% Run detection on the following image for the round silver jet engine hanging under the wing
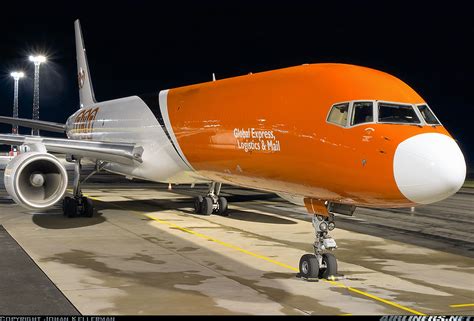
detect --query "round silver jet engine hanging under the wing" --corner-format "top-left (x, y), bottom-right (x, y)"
top-left (4, 152), bottom-right (68, 210)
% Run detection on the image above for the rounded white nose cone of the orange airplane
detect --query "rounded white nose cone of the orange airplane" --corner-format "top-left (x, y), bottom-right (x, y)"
top-left (393, 133), bottom-right (466, 204)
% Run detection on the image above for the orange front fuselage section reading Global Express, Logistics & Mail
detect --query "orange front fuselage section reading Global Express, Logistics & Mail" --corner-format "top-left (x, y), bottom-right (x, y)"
top-left (167, 64), bottom-right (449, 207)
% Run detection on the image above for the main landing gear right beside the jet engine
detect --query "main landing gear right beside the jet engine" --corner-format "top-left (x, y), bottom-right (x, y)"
top-left (63, 158), bottom-right (97, 217)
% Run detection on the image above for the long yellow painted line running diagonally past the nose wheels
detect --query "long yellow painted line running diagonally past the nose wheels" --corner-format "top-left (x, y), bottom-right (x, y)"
top-left (84, 194), bottom-right (426, 315)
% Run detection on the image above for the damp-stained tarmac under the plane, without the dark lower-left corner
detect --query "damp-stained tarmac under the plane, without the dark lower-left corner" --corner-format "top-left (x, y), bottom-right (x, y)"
top-left (0, 169), bottom-right (474, 315)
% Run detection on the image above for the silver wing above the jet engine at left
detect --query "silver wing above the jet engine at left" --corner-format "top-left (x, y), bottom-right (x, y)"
top-left (0, 134), bottom-right (143, 165)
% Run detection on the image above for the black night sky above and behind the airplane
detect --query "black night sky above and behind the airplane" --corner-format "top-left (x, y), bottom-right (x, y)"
top-left (0, 0), bottom-right (474, 168)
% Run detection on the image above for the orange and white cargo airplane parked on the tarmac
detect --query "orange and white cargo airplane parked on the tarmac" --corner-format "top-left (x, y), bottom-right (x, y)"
top-left (0, 21), bottom-right (466, 279)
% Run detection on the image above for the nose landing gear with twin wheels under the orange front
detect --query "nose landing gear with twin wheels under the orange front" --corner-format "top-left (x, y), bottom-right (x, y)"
top-left (298, 213), bottom-right (337, 280)
